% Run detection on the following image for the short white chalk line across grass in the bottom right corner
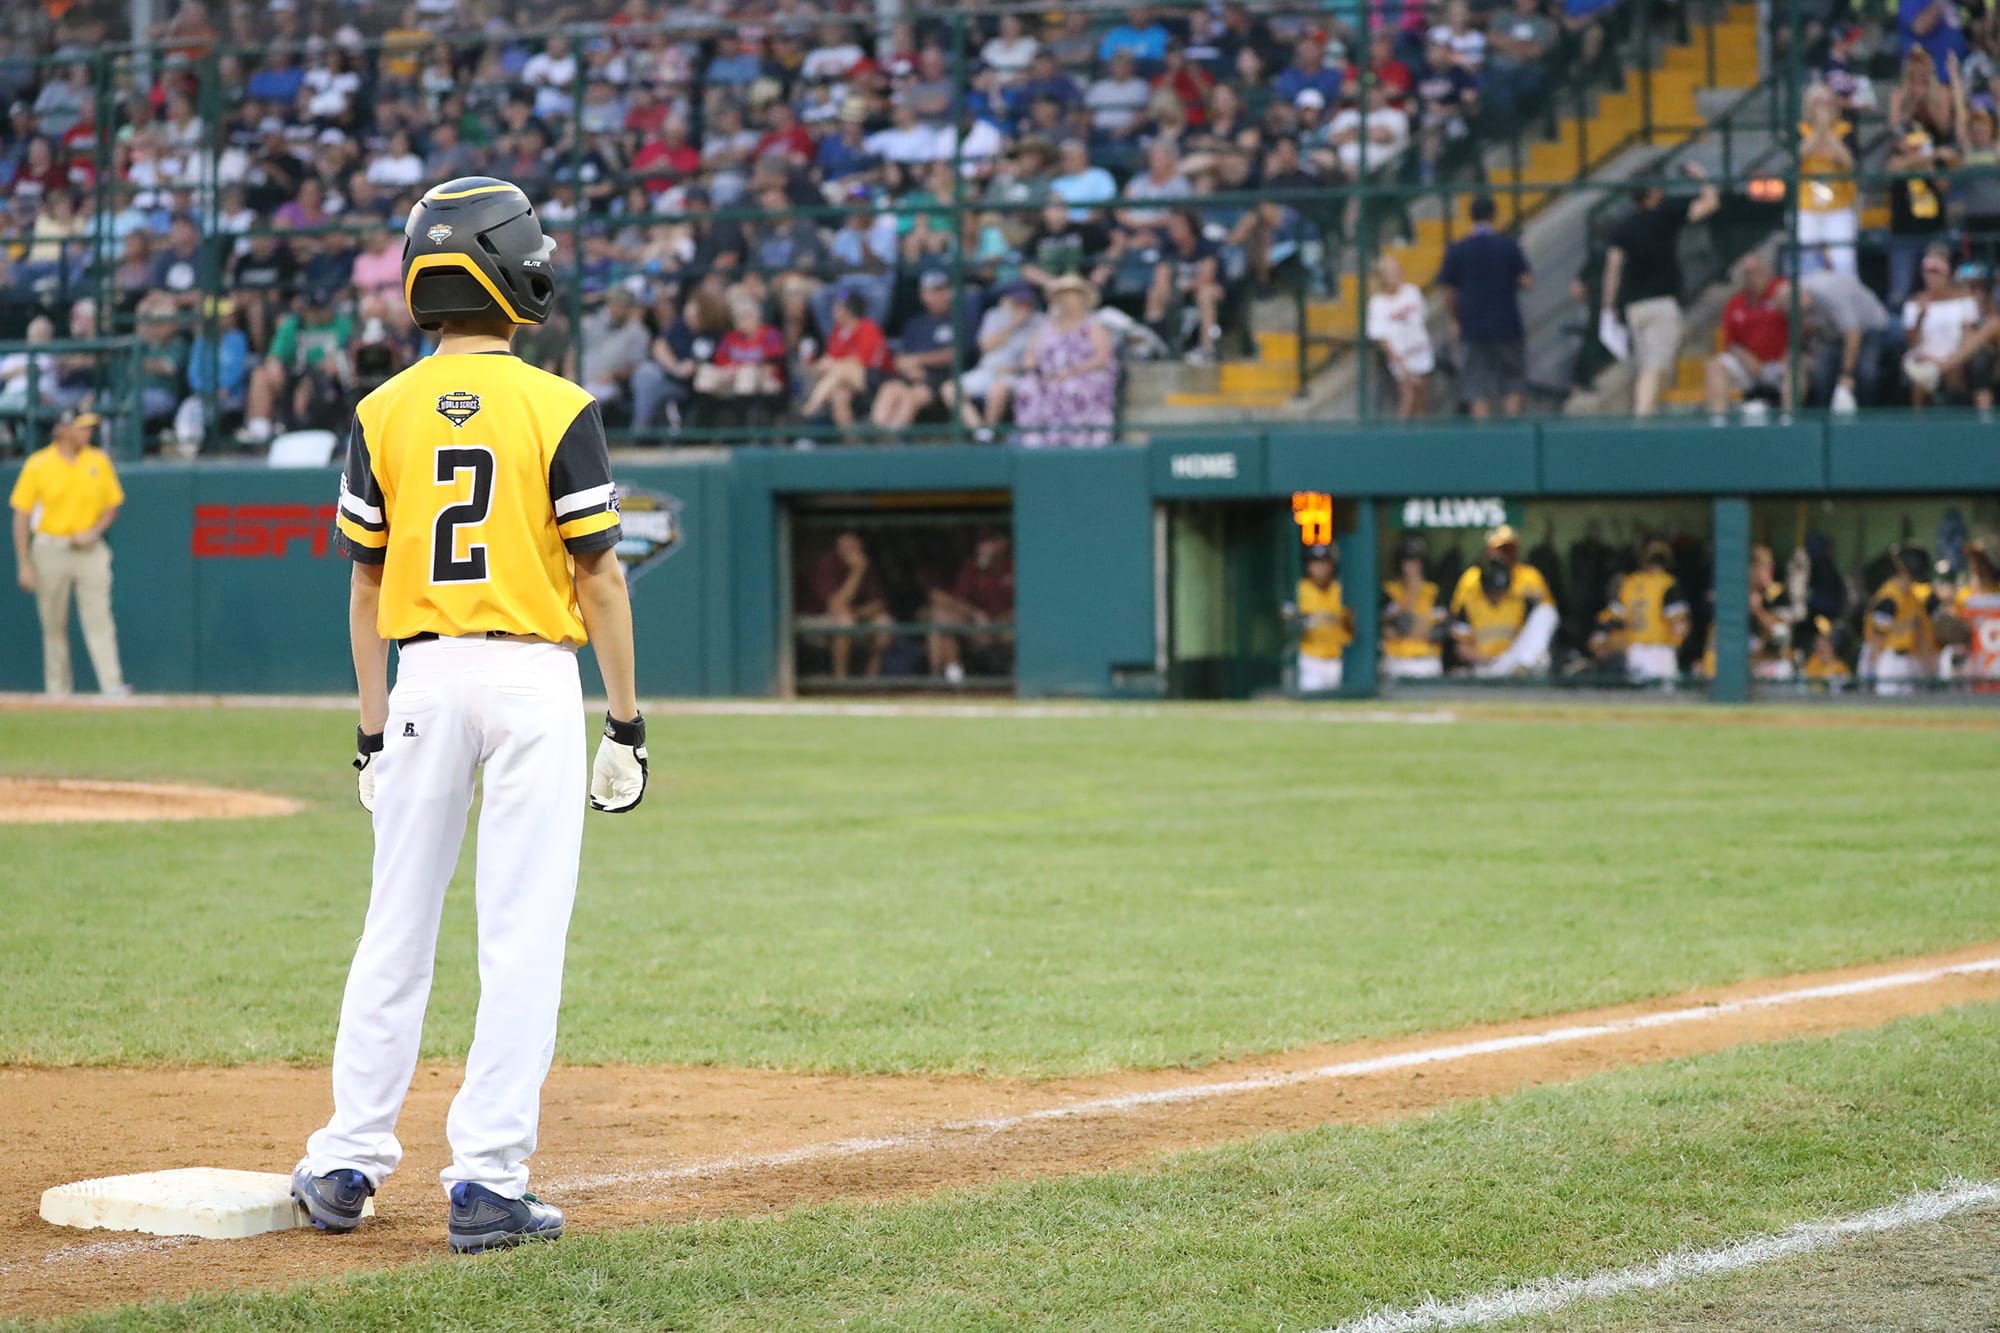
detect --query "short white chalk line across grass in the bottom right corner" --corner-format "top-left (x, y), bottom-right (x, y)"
top-left (1322, 1181), bottom-right (2000, 1333)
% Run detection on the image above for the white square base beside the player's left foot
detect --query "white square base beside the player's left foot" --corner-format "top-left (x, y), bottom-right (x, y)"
top-left (42, 1167), bottom-right (374, 1241)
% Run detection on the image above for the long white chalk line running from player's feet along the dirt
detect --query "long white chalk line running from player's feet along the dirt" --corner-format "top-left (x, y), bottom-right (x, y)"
top-left (550, 959), bottom-right (2000, 1191)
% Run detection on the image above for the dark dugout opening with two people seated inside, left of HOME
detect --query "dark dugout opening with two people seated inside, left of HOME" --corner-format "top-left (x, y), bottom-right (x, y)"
top-left (778, 490), bottom-right (1014, 697)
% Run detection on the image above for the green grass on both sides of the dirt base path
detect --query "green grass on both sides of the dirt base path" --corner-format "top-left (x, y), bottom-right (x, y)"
top-left (0, 711), bottom-right (2000, 1329)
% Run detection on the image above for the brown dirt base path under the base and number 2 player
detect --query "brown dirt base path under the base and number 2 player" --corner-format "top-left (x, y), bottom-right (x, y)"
top-left (11, 947), bottom-right (2000, 1315)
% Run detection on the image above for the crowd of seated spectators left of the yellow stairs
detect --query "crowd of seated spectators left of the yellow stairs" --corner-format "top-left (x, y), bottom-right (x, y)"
top-left (0, 0), bottom-right (1600, 448)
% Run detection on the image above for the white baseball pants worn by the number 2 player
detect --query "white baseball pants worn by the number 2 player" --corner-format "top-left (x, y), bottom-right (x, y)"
top-left (306, 638), bottom-right (588, 1197)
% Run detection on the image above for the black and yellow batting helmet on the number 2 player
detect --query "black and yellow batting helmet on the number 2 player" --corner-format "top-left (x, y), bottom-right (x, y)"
top-left (402, 176), bottom-right (556, 328)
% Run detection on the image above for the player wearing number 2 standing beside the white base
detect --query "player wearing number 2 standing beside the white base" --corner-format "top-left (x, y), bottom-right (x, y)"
top-left (292, 176), bottom-right (646, 1253)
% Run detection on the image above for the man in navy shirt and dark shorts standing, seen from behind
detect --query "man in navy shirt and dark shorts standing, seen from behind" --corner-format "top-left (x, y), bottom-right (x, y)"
top-left (1438, 193), bottom-right (1534, 418)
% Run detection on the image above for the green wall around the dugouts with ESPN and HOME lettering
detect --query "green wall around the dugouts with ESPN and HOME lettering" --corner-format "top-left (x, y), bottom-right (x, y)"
top-left (0, 414), bottom-right (2000, 701)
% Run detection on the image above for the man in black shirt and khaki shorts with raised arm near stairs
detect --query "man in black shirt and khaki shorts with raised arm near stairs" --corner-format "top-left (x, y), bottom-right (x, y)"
top-left (1602, 162), bottom-right (1722, 416)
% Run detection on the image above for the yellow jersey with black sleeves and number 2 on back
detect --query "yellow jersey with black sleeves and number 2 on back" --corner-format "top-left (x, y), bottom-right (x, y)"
top-left (336, 352), bottom-right (624, 642)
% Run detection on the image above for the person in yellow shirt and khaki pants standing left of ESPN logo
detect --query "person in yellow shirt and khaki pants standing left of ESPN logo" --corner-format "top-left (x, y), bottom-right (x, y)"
top-left (10, 410), bottom-right (130, 695)
